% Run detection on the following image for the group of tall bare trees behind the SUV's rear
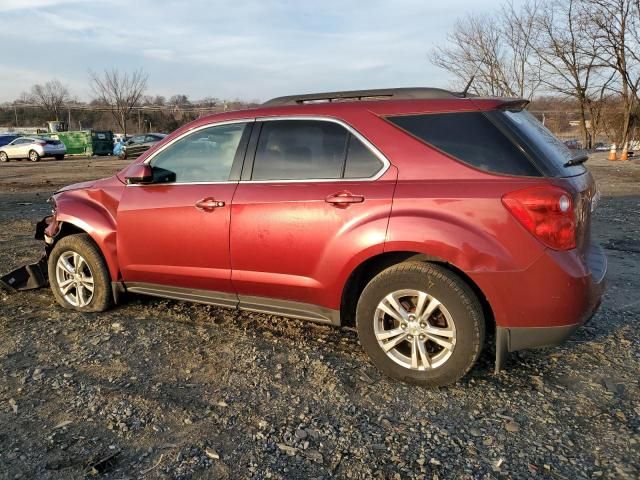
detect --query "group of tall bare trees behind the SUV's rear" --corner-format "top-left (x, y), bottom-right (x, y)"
top-left (430, 0), bottom-right (640, 147)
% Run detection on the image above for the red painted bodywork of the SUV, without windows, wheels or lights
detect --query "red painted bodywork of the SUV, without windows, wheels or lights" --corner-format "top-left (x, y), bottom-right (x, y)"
top-left (47, 99), bottom-right (602, 338)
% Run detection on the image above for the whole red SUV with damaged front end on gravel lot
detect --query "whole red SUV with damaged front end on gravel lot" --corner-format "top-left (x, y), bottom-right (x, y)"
top-left (37, 88), bottom-right (606, 385)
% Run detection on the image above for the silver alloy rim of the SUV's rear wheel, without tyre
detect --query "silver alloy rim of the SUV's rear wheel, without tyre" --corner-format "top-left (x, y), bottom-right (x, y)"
top-left (373, 290), bottom-right (456, 371)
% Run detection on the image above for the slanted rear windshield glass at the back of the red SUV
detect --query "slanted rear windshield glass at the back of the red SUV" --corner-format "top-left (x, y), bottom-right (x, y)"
top-left (502, 110), bottom-right (585, 177)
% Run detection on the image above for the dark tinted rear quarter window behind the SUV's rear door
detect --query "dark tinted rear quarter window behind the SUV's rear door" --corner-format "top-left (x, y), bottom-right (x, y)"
top-left (388, 112), bottom-right (540, 177)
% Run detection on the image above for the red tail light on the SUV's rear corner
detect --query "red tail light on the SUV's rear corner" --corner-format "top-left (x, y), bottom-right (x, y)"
top-left (502, 186), bottom-right (576, 250)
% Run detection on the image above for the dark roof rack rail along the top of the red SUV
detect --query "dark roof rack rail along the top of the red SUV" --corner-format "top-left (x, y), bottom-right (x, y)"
top-left (262, 87), bottom-right (465, 107)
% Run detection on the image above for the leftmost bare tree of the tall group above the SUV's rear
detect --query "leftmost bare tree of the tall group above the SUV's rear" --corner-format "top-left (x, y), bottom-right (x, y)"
top-left (430, 0), bottom-right (540, 98)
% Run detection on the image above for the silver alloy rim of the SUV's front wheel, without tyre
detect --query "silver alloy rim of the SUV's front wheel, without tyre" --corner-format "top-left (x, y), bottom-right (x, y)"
top-left (56, 251), bottom-right (94, 307)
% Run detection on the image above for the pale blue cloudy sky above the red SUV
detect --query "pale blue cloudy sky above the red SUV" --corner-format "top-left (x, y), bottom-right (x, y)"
top-left (0, 0), bottom-right (510, 102)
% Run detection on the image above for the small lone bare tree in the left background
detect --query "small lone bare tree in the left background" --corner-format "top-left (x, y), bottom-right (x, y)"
top-left (89, 68), bottom-right (148, 135)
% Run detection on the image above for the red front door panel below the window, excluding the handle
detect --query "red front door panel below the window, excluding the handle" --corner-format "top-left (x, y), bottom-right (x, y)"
top-left (117, 183), bottom-right (237, 292)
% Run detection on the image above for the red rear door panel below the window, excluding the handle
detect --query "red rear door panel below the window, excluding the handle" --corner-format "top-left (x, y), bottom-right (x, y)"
top-left (231, 168), bottom-right (396, 309)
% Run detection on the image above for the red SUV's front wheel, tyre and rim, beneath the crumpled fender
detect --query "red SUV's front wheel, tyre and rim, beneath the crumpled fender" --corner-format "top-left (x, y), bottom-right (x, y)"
top-left (49, 234), bottom-right (112, 312)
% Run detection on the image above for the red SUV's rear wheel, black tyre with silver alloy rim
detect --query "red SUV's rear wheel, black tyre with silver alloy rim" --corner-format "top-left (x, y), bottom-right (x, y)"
top-left (356, 262), bottom-right (485, 386)
